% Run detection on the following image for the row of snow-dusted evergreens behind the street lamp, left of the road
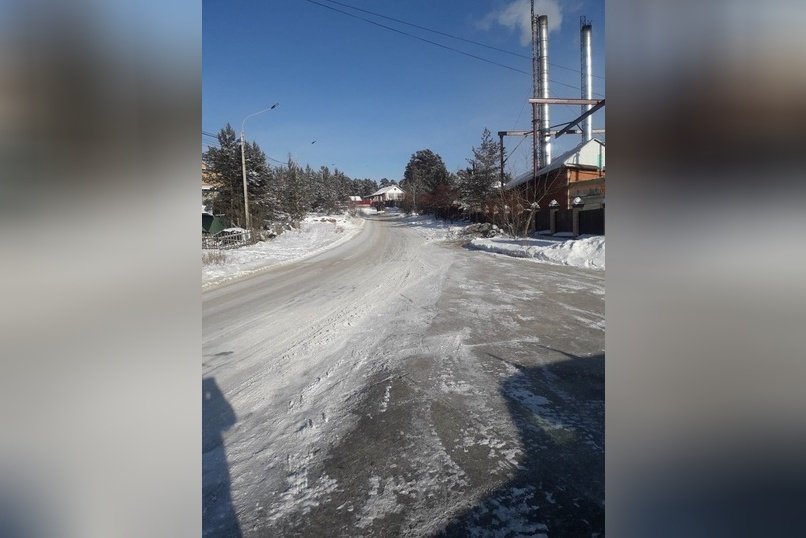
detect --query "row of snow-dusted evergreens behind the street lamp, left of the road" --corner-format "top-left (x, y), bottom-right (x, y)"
top-left (202, 124), bottom-right (393, 227)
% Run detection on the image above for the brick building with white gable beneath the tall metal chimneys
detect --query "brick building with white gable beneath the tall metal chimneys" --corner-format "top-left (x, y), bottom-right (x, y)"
top-left (504, 138), bottom-right (605, 209)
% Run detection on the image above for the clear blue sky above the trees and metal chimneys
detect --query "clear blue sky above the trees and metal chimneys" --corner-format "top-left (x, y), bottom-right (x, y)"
top-left (202, 0), bottom-right (605, 180)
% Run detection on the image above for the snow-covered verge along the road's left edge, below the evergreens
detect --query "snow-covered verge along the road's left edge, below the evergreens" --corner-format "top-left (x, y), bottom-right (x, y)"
top-left (202, 215), bottom-right (364, 288)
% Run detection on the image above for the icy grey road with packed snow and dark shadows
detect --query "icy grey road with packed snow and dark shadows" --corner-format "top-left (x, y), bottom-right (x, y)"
top-left (202, 216), bottom-right (605, 537)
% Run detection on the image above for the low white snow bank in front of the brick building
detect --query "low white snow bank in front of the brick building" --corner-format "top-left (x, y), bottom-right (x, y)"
top-left (470, 235), bottom-right (605, 270)
